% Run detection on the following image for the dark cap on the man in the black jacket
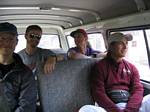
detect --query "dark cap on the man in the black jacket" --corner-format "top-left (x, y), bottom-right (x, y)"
top-left (0, 22), bottom-right (18, 35)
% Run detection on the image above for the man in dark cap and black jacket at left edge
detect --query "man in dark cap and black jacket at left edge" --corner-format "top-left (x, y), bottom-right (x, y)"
top-left (0, 22), bottom-right (37, 112)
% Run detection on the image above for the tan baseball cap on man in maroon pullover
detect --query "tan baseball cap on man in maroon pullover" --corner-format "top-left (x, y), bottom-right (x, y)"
top-left (108, 32), bottom-right (133, 44)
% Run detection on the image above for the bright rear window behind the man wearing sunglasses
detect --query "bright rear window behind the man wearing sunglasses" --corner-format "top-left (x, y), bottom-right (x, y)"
top-left (15, 35), bottom-right (60, 52)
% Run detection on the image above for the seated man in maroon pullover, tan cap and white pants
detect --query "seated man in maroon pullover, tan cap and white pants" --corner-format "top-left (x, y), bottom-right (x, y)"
top-left (79, 33), bottom-right (150, 112)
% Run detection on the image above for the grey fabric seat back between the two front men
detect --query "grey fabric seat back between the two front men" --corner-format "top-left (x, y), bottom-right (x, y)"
top-left (38, 59), bottom-right (96, 112)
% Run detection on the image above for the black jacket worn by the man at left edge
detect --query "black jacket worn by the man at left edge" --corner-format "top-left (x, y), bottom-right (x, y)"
top-left (0, 53), bottom-right (37, 112)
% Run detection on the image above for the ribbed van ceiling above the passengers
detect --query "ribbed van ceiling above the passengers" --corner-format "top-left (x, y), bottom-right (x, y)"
top-left (0, 0), bottom-right (150, 29)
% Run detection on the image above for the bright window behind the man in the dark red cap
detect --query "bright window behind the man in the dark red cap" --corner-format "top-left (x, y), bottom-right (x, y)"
top-left (67, 33), bottom-right (106, 52)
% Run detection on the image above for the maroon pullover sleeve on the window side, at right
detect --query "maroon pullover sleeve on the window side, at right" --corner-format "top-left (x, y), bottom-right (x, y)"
top-left (125, 65), bottom-right (143, 112)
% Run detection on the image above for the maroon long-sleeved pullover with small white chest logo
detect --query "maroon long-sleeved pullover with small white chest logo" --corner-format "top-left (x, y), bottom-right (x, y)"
top-left (92, 57), bottom-right (143, 112)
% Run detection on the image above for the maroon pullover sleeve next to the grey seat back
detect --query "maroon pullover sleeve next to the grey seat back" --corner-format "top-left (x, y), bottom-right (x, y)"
top-left (91, 64), bottom-right (123, 112)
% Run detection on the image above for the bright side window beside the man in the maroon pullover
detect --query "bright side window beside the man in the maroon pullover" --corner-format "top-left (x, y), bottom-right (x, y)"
top-left (112, 30), bottom-right (150, 81)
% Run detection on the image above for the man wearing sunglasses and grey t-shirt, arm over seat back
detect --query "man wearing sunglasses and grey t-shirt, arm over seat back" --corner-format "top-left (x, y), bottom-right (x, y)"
top-left (19, 25), bottom-right (60, 74)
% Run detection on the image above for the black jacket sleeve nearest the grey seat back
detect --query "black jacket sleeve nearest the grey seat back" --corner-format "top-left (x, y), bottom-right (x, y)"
top-left (15, 70), bottom-right (37, 112)
